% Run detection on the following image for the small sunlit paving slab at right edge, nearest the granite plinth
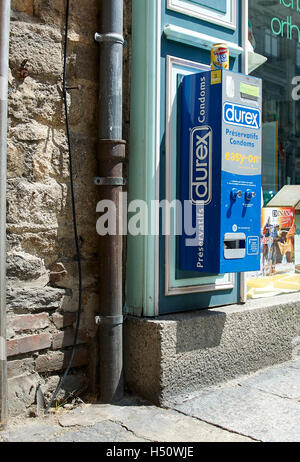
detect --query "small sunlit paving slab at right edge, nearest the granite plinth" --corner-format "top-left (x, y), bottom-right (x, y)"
top-left (241, 361), bottom-right (300, 400)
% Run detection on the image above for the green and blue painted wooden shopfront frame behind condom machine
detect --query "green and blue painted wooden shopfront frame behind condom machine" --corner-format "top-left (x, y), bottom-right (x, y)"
top-left (126, 0), bottom-right (247, 317)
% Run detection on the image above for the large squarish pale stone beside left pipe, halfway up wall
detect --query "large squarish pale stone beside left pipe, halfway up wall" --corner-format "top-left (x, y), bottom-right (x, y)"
top-left (7, 179), bottom-right (65, 232)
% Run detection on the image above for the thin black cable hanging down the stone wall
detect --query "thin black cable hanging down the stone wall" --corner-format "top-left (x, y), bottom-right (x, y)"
top-left (45, 0), bottom-right (82, 414)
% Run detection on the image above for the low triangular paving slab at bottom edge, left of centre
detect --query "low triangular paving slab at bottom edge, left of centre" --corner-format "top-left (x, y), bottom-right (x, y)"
top-left (50, 421), bottom-right (146, 443)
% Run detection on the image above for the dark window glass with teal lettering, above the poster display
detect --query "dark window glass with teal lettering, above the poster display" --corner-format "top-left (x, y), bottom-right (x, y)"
top-left (249, 0), bottom-right (300, 199)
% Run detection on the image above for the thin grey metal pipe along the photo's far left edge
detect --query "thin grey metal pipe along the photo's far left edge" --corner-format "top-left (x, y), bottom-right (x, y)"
top-left (0, 0), bottom-right (10, 430)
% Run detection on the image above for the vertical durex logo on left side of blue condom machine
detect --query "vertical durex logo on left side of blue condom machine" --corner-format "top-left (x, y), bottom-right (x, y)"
top-left (190, 125), bottom-right (213, 205)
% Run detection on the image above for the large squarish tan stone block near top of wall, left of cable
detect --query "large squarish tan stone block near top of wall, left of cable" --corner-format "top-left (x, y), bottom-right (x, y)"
top-left (9, 21), bottom-right (62, 81)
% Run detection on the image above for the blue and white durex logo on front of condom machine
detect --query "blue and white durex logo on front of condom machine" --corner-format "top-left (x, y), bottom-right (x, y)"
top-left (223, 103), bottom-right (261, 130)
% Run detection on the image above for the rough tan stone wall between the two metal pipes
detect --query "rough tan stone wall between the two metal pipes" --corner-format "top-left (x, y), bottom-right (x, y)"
top-left (7, 0), bottom-right (100, 415)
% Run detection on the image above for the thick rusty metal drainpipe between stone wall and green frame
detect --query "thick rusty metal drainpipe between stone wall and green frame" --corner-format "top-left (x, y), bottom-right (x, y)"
top-left (95, 0), bottom-right (125, 403)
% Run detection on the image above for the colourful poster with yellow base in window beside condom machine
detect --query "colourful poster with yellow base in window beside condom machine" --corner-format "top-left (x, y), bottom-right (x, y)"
top-left (247, 207), bottom-right (300, 298)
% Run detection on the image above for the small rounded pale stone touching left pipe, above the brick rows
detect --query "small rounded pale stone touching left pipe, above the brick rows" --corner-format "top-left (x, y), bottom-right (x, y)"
top-left (6, 251), bottom-right (47, 281)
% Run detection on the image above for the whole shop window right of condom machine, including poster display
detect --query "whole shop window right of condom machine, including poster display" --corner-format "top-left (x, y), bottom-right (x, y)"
top-left (248, 0), bottom-right (300, 298)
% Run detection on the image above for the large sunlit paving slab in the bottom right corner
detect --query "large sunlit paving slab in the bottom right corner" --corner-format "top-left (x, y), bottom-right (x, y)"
top-left (175, 386), bottom-right (300, 442)
